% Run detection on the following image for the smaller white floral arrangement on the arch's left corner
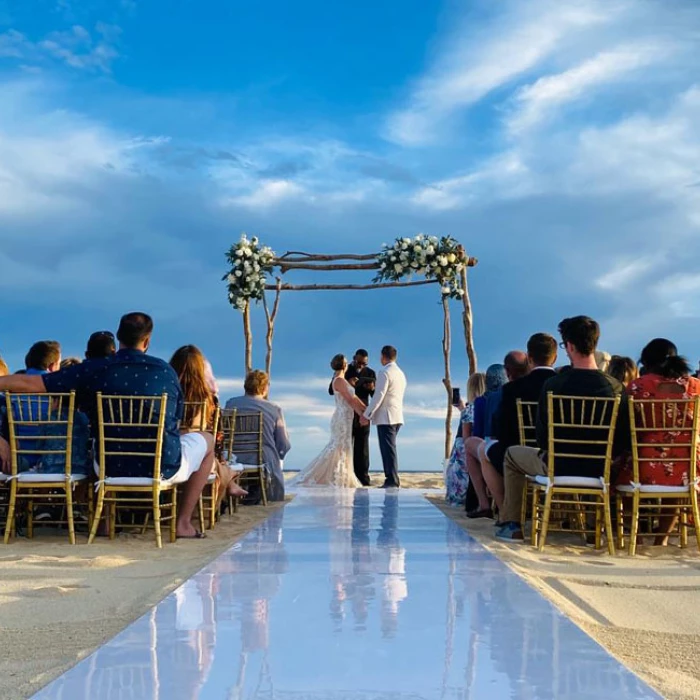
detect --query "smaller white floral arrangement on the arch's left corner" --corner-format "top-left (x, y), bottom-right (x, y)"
top-left (223, 233), bottom-right (275, 311)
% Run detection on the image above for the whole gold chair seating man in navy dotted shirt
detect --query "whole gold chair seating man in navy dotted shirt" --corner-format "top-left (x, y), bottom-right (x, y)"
top-left (88, 392), bottom-right (177, 548)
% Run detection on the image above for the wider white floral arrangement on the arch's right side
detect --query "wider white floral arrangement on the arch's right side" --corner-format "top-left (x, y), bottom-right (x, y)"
top-left (374, 233), bottom-right (467, 299)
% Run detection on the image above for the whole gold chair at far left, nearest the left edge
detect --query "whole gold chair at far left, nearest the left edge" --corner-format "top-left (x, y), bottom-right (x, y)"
top-left (5, 391), bottom-right (87, 544)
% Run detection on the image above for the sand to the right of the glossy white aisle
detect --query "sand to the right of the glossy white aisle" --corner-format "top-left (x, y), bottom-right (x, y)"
top-left (429, 495), bottom-right (700, 700)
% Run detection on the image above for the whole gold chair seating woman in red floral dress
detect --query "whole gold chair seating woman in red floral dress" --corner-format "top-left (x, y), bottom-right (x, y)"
top-left (617, 396), bottom-right (700, 555)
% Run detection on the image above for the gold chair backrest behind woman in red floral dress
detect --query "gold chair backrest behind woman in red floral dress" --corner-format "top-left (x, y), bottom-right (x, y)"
top-left (629, 396), bottom-right (700, 486)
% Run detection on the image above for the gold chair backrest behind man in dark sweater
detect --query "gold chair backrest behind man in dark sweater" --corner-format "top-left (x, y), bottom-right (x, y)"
top-left (547, 391), bottom-right (621, 484)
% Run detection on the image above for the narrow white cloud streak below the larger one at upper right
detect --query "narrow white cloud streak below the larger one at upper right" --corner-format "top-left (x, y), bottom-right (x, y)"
top-left (507, 43), bottom-right (671, 134)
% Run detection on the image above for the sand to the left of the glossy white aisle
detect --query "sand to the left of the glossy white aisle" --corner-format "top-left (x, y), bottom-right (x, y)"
top-left (0, 504), bottom-right (280, 700)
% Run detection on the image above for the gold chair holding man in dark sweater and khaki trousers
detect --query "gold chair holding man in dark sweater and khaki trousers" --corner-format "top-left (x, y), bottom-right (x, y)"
top-left (532, 392), bottom-right (620, 554)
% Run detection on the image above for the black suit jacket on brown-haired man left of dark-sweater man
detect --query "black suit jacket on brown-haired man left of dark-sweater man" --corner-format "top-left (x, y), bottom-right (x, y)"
top-left (488, 367), bottom-right (555, 474)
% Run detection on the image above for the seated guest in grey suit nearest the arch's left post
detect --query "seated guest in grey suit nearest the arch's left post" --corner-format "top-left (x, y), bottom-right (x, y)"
top-left (226, 370), bottom-right (292, 501)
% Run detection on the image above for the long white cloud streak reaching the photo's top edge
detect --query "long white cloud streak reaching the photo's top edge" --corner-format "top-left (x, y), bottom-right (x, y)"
top-left (386, 0), bottom-right (617, 146)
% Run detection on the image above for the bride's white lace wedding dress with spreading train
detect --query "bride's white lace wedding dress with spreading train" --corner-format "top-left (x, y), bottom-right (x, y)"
top-left (293, 387), bottom-right (362, 489)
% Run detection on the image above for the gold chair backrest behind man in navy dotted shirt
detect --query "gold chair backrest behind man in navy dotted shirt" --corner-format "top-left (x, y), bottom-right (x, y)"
top-left (97, 392), bottom-right (168, 481)
